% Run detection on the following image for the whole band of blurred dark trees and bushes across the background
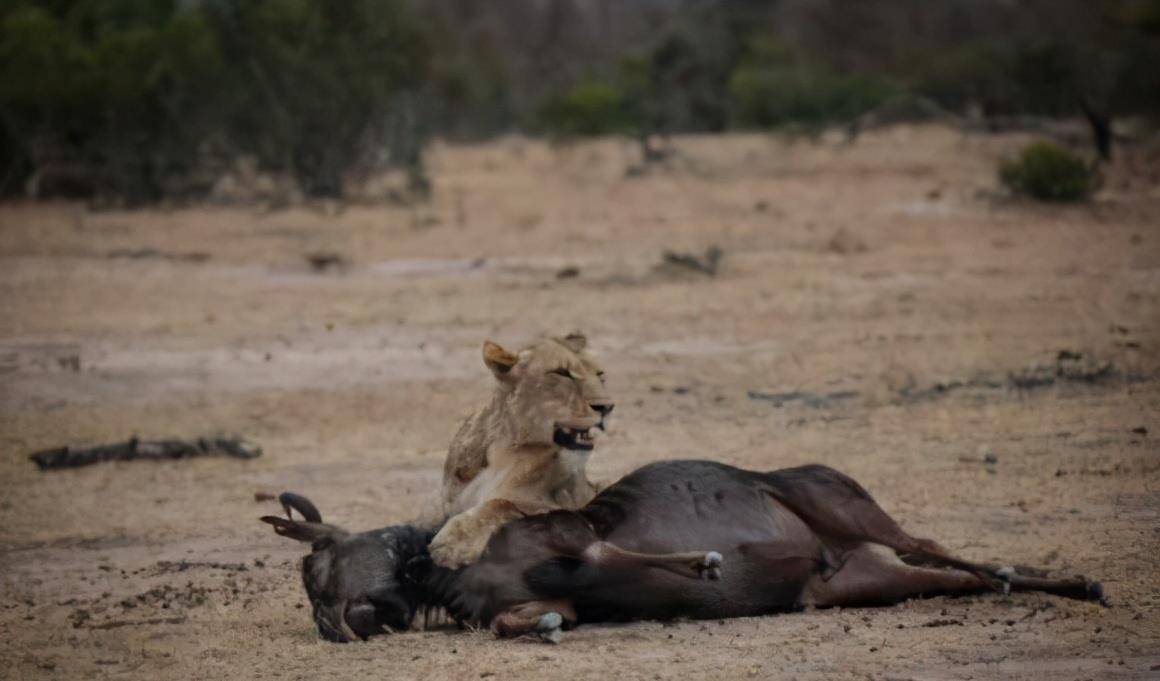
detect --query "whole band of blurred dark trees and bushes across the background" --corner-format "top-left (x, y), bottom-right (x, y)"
top-left (0, 0), bottom-right (1160, 204)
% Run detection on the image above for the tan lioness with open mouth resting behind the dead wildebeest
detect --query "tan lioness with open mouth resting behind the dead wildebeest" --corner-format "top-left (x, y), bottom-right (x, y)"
top-left (430, 333), bottom-right (614, 567)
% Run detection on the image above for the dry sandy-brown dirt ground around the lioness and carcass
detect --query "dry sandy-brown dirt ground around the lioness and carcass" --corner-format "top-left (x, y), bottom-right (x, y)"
top-left (0, 128), bottom-right (1160, 680)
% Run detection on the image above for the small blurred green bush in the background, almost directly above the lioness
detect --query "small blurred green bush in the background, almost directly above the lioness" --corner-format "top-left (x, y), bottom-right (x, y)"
top-left (539, 80), bottom-right (633, 136)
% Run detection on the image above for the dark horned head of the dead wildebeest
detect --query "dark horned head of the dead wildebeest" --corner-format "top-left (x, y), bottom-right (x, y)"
top-left (261, 492), bottom-right (432, 643)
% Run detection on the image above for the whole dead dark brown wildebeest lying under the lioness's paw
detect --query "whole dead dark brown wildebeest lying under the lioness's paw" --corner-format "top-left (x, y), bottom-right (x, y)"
top-left (263, 461), bottom-right (1102, 640)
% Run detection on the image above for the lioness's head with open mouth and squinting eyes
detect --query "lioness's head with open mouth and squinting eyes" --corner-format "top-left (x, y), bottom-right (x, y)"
top-left (484, 333), bottom-right (615, 451)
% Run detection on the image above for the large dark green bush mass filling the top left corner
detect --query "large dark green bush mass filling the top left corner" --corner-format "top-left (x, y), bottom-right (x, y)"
top-left (0, 0), bottom-right (430, 202)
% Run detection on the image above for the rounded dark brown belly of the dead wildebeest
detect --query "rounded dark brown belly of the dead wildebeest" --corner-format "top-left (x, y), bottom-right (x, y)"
top-left (575, 462), bottom-right (822, 621)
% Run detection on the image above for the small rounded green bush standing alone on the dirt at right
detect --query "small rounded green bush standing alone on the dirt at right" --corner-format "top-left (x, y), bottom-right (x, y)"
top-left (999, 142), bottom-right (1100, 201)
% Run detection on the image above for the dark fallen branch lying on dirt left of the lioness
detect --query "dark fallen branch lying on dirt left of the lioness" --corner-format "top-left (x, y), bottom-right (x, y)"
top-left (29, 437), bottom-right (262, 471)
